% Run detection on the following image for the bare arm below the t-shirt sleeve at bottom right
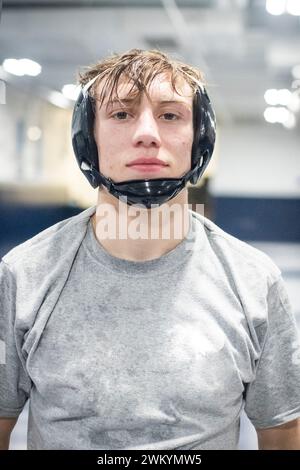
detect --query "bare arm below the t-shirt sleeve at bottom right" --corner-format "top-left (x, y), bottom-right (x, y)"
top-left (256, 418), bottom-right (300, 450)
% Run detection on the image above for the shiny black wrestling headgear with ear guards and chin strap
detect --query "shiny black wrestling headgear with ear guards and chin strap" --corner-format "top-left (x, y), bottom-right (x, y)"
top-left (72, 77), bottom-right (216, 208)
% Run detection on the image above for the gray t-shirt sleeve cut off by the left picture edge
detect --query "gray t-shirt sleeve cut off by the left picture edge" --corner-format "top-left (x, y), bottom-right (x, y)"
top-left (0, 261), bottom-right (31, 418)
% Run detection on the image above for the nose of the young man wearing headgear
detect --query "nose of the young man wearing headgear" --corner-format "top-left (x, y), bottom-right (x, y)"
top-left (133, 110), bottom-right (161, 147)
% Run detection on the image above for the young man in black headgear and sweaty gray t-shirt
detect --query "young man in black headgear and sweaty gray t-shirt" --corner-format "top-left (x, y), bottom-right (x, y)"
top-left (0, 49), bottom-right (300, 449)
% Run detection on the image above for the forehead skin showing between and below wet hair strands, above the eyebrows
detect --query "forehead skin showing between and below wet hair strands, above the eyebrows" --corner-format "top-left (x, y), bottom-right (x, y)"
top-left (97, 74), bottom-right (194, 104)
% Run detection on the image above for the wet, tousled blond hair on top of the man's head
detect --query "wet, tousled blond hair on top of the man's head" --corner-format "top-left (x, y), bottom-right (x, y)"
top-left (79, 49), bottom-right (204, 106)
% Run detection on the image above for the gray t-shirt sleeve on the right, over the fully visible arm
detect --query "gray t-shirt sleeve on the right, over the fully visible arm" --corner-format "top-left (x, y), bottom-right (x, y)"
top-left (245, 276), bottom-right (300, 429)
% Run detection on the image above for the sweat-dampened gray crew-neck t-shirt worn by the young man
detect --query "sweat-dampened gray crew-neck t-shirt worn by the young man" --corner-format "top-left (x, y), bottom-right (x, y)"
top-left (0, 208), bottom-right (300, 450)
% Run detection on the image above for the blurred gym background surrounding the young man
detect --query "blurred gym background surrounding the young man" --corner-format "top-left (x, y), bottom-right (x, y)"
top-left (0, 0), bottom-right (300, 449)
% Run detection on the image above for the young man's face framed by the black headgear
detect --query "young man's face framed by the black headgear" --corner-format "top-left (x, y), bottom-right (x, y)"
top-left (94, 75), bottom-right (193, 182)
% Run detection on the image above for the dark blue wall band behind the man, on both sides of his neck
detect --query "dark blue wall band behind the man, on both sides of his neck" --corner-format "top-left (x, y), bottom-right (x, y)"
top-left (0, 197), bottom-right (300, 256)
